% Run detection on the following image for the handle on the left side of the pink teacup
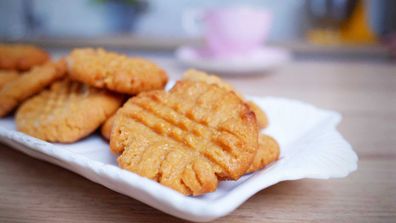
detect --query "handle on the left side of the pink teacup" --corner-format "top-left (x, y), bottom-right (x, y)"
top-left (182, 9), bottom-right (204, 36)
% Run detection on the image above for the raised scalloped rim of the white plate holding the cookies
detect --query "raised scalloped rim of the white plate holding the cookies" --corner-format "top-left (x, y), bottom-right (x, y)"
top-left (0, 96), bottom-right (358, 221)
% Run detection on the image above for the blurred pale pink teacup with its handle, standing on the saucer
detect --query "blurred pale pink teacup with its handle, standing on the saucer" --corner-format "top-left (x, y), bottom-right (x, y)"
top-left (183, 7), bottom-right (272, 57)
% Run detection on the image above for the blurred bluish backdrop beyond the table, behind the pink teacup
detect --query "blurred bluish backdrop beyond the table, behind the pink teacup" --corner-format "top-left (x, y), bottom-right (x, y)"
top-left (0, 0), bottom-right (396, 57)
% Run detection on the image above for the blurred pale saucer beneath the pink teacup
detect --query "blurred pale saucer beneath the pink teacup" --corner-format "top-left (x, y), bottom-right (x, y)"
top-left (175, 46), bottom-right (291, 75)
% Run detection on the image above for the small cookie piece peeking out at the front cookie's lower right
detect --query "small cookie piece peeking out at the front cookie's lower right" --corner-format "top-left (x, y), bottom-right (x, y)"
top-left (246, 135), bottom-right (280, 173)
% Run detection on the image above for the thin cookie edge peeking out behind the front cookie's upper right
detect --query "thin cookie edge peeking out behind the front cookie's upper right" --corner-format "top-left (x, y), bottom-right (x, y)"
top-left (182, 69), bottom-right (268, 129)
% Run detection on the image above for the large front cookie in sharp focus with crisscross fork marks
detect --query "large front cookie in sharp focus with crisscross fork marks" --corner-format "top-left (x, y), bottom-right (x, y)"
top-left (110, 81), bottom-right (258, 195)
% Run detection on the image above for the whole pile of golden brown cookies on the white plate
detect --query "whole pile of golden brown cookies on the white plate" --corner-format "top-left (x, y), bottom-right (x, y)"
top-left (0, 46), bottom-right (279, 196)
